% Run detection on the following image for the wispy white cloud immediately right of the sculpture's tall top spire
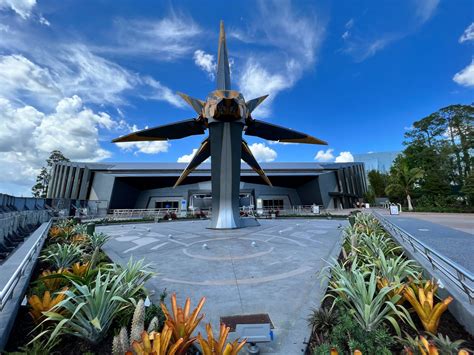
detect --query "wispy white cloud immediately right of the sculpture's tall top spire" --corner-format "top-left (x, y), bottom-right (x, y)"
top-left (236, 1), bottom-right (326, 117)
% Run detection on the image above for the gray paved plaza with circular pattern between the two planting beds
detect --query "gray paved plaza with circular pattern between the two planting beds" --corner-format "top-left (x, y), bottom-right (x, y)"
top-left (97, 219), bottom-right (347, 354)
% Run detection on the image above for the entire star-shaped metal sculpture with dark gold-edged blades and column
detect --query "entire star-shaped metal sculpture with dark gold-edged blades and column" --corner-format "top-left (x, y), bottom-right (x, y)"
top-left (113, 21), bottom-right (327, 229)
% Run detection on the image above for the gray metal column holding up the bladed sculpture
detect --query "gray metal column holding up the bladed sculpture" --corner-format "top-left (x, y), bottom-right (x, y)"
top-left (209, 122), bottom-right (243, 229)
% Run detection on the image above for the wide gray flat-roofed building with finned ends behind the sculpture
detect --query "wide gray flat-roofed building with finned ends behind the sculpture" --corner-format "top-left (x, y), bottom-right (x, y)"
top-left (48, 162), bottom-right (367, 209)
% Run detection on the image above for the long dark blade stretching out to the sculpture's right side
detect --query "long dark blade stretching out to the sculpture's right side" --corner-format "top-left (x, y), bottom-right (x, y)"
top-left (245, 120), bottom-right (327, 145)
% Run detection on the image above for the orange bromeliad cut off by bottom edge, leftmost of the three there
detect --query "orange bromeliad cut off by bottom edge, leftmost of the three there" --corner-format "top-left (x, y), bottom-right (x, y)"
top-left (130, 325), bottom-right (183, 355)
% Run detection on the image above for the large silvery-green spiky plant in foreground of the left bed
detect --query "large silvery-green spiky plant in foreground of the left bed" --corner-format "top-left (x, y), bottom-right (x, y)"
top-left (37, 271), bottom-right (133, 344)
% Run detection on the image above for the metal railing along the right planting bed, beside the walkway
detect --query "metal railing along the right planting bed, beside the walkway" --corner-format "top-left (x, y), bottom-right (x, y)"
top-left (371, 211), bottom-right (474, 304)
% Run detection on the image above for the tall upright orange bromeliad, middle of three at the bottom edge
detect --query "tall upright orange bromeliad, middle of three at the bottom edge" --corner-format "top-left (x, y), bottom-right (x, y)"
top-left (161, 293), bottom-right (206, 355)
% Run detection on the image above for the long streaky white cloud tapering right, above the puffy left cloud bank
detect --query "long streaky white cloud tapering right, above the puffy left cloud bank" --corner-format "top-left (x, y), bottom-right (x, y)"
top-left (0, 45), bottom-right (184, 107)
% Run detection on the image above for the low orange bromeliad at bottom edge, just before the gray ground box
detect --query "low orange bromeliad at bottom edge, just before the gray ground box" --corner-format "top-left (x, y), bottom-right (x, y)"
top-left (197, 323), bottom-right (247, 355)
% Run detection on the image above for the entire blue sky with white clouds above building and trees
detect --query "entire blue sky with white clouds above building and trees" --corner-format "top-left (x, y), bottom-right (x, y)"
top-left (0, 0), bottom-right (474, 195)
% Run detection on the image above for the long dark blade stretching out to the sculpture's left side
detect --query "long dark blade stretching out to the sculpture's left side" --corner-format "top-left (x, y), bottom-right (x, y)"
top-left (112, 118), bottom-right (206, 143)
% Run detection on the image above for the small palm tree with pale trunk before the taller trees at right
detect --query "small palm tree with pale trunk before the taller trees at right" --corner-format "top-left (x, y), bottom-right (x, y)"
top-left (385, 157), bottom-right (424, 211)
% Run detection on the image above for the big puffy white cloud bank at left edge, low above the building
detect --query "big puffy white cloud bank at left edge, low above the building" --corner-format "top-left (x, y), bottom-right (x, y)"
top-left (0, 96), bottom-right (117, 194)
